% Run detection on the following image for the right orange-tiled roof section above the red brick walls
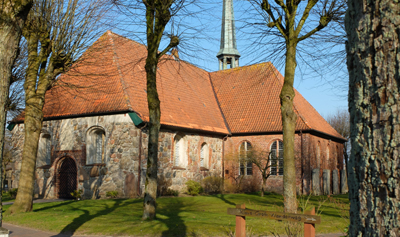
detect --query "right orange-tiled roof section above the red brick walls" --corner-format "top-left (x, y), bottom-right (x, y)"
top-left (210, 62), bottom-right (344, 139)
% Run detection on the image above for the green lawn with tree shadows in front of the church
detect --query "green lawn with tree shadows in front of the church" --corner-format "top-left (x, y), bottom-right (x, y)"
top-left (4, 194), bottom-right (349, 236)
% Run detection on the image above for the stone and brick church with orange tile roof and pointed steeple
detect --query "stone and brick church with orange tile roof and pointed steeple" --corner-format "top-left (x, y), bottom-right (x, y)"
top-left (7, 0), bottom-right (346, 198)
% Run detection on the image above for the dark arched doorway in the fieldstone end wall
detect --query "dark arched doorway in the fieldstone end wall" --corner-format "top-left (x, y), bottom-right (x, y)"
top-left (58, 157), bottom-right (77, 198)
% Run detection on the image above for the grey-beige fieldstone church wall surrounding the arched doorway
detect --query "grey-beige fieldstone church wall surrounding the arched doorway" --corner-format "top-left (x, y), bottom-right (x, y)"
top-left (12, 114), bottom-right (222, 198)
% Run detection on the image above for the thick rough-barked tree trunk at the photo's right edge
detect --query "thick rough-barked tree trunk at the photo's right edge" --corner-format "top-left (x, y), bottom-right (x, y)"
top-left (346, 0), bottom-right (400, 236)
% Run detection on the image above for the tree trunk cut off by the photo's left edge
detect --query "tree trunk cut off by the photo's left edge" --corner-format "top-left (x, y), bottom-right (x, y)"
top-left (0, 0), bottom-right (32, 223)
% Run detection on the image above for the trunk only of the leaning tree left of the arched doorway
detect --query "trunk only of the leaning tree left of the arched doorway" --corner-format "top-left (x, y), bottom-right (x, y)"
top-left (7, 30), bottom-right (49, 214)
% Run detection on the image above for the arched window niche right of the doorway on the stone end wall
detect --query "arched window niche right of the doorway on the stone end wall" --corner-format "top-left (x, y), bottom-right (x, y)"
top-left (86, 127), bottom-right (105, 165)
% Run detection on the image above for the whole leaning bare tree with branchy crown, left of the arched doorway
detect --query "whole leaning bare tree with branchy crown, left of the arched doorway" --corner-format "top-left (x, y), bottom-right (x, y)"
top-left (8, 0), bottom-right (104, 213)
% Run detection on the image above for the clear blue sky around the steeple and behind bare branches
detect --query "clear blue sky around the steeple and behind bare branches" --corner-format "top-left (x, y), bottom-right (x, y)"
top-left (116, 0), bottom-right (347, 117)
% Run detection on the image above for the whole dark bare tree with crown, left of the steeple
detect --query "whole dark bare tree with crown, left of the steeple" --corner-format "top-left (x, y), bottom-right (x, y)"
top-left (111, 0), bottom-right (199, 220)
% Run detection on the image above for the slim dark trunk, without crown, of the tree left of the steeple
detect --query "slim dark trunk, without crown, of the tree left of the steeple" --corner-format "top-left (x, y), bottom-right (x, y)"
top-left (142, 51), bottom-right (161, 220)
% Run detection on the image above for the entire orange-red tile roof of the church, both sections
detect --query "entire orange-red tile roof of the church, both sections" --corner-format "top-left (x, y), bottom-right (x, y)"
top-left (15, 31), bottom-right (343, 139)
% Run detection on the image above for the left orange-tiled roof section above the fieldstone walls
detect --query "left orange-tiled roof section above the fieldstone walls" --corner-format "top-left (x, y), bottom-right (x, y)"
top-left (16, 32), bottom-right (229, 134)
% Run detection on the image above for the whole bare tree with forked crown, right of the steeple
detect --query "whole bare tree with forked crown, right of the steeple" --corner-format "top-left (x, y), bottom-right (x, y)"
top-left (245, 0), bottom-right (345, 213)
